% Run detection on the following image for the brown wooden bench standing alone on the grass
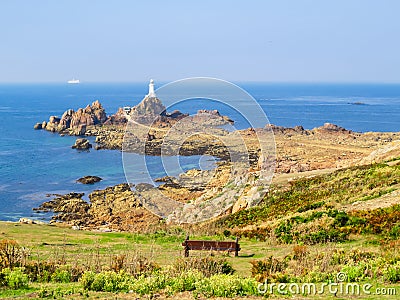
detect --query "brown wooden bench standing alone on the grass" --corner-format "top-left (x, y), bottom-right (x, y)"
top-left (182, 236), bottom-right (240, 257)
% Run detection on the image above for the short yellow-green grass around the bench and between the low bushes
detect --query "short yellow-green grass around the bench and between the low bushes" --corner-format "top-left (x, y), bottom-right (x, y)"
top-left (0, 222), bottom-right (400, 299)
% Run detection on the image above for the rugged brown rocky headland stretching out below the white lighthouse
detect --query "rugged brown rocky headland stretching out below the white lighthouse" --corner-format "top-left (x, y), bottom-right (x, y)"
top-left (35, 97), bottom-right (400, 231)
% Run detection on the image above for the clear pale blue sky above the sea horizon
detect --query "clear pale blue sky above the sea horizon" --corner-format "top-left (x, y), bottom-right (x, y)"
top-left (0, 0), bottom-right (400, 82)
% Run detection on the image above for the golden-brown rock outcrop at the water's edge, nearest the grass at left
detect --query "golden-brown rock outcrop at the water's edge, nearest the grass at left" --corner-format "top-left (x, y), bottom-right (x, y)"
top-left (34, 184), bottom-right (160, 232)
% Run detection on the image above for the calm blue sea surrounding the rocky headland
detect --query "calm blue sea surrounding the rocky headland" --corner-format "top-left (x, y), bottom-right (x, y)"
top-left (0, 83), bottom-right (400, 221)
